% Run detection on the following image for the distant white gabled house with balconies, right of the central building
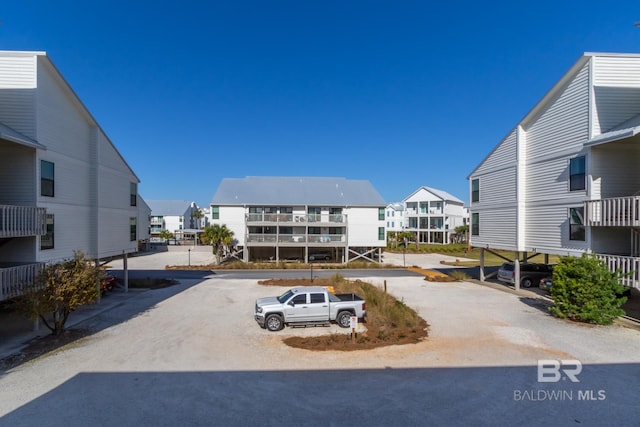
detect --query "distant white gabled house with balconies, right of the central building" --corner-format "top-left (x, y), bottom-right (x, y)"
top-left (403, 187), bottom-right (465, 244)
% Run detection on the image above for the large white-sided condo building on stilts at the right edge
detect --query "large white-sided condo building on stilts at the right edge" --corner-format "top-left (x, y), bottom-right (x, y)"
top-left (468, 53), bottom-right (640, 287)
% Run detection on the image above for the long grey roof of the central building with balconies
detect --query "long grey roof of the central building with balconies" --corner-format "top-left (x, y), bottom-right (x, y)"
top-left (211, 176), bottom-right (386, 207)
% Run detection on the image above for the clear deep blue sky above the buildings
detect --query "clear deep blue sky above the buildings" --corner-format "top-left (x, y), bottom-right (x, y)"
top-left (0, 0), bottom-right (640, 206)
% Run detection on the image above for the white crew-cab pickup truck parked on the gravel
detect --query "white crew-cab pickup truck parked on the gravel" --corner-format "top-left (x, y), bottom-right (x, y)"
top-left (254, 286), bottom-right (367, 331)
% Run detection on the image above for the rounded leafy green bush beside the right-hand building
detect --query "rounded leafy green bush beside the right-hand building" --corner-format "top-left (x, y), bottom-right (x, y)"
top-left (549, 254), bottom-right (627, 325)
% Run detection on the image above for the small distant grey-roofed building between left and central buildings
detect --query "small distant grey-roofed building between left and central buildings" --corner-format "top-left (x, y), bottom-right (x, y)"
top-left (147, 200), bottom-right (204, 239)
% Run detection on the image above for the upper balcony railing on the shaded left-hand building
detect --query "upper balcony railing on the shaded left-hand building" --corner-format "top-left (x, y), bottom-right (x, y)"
top-left (0, 205), bottom-right (47, 238)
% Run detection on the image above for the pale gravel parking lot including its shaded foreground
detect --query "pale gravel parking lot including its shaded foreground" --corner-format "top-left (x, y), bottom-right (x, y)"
top-left (0, 254), bottom-right (640, 426)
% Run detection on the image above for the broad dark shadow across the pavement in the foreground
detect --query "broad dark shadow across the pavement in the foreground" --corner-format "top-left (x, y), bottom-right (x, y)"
top-left (2, 364), bottom-right (640, 427)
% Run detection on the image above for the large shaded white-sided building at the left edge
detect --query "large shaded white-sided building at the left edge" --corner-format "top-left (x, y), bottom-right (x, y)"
top-left (0, 51), bottom-right (149, 300)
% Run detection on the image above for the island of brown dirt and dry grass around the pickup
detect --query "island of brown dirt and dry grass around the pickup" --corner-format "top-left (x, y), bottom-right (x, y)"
top-left (258, 278), bottom-right (429, 351)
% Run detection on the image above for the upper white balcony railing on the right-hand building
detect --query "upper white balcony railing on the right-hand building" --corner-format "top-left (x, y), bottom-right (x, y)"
top-left (585, 196), bottom-right (640, 227)
